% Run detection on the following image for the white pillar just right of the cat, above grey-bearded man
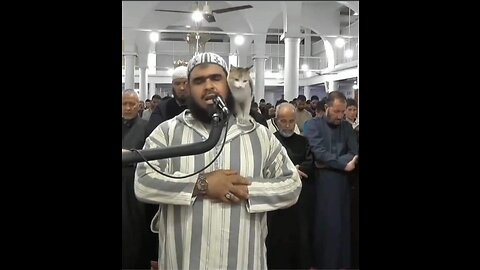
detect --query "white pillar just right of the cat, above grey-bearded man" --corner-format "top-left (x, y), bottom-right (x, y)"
top-left (283, 37), bottom-right (300, 101)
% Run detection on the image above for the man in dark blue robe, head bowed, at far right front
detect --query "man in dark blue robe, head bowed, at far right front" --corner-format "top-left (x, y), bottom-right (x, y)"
top-left (305, 91), bottom-right (358, 269)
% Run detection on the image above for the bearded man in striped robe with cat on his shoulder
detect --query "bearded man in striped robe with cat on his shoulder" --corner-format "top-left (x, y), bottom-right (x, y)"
top-left (135, 52), bottom-right (302, 269)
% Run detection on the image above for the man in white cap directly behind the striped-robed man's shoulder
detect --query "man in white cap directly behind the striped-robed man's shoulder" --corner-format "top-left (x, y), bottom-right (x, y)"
top-left (147, 66), bottom-right (189, 136)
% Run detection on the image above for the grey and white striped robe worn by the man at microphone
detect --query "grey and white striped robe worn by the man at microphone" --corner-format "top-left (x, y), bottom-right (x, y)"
top-left (135, 110), bottom-right (302, 269)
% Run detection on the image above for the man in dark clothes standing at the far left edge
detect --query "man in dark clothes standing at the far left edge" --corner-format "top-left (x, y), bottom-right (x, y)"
top-left (122, 89), bottom-right (157, 269)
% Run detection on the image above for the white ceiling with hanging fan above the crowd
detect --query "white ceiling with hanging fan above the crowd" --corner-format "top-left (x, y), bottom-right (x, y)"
top-left (122, 1), bottom-right (358, 50)
